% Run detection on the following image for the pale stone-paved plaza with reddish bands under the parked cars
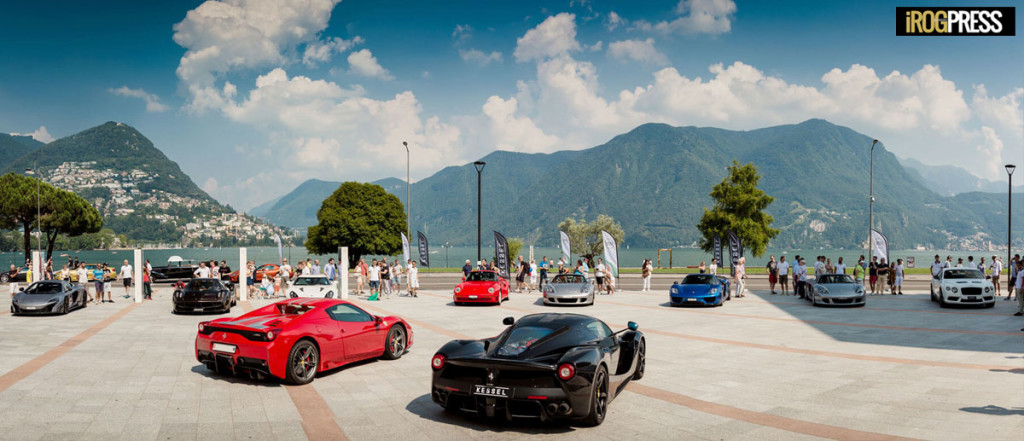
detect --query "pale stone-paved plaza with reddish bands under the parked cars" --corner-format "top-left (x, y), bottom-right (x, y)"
top-left (0, 282), bottom-right (1024, 441)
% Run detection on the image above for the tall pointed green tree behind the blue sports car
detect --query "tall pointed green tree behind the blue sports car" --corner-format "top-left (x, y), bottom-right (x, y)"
top-left (697, 160), bottom-right (779, 257)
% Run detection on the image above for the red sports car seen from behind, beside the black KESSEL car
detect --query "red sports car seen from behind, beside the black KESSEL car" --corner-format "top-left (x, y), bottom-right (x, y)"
top-left (196, 298), bottom-right (413, 385)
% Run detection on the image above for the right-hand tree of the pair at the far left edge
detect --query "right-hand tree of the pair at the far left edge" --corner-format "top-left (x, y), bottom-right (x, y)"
top-left (40, 188), bottom-right (103, 259)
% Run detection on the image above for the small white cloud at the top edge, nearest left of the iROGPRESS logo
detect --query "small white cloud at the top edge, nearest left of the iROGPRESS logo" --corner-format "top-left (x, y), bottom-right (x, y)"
top-left (634, 0), bottom-right (736, 35)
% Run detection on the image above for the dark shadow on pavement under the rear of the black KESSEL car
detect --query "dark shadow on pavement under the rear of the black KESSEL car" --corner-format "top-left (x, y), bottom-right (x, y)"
top-left (406, 394), bottom-right (575, 435)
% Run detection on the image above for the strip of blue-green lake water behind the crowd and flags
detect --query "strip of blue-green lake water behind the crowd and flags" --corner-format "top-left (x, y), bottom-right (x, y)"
top-left (0, 242), bottom-right (991, 269)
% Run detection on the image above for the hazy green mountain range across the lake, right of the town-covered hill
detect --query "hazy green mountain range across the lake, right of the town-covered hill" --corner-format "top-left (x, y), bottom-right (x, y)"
top-left (254, 120), bottom-right (1022, 249)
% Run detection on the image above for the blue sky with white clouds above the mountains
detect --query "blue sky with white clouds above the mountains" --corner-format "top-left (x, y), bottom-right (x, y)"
top-left (0, 0), bottom-right (1024, 210)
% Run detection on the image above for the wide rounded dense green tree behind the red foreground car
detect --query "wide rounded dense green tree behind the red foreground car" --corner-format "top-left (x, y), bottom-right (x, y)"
top-left (305, 182), bottom-right (406, 267)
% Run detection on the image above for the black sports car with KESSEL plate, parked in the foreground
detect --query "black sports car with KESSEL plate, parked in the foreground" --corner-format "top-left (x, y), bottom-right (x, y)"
top-left (430, 314), bottom-right (646, 426)
